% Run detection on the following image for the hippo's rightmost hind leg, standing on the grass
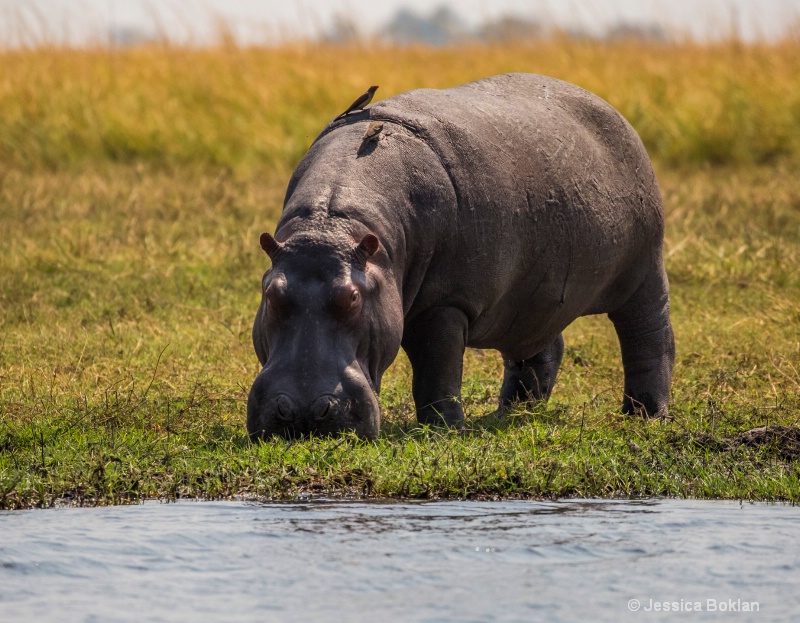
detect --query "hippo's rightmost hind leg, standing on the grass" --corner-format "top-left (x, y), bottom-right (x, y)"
top-left (608, 268), bottom-right (675, 417)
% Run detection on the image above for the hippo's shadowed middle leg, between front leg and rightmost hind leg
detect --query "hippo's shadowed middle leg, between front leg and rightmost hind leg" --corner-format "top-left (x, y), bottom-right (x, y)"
top-left (500, 333), bottom-right (564, 411)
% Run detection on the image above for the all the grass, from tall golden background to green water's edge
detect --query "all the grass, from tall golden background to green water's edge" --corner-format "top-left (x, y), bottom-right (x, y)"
top-left (0, 41), bottom-right (800, 508)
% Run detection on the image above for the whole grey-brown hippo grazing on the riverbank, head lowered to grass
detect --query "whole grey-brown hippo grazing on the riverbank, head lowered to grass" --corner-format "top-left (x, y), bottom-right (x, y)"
top-left (247, 74), bottom-right (675, 438)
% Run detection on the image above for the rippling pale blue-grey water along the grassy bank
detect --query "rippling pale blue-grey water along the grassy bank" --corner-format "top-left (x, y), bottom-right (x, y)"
top-left (0, 500), bottom-right (800, 623)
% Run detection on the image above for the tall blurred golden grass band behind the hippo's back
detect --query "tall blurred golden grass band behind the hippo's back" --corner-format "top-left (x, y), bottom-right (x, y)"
top-left (0, 39), bottom-right (800, 171)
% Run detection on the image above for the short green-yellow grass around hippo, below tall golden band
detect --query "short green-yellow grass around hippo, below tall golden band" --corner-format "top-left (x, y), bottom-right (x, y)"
top-left (0, 164), bottom-right (800, 508)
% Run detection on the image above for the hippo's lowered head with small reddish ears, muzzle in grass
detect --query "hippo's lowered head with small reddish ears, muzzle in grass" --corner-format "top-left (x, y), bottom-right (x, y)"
top-left (247, 225), bottom-right (403, 438)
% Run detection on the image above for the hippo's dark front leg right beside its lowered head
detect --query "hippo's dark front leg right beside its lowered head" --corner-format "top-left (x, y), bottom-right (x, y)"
top-left (402, 307), bottom-right (467, 426)
